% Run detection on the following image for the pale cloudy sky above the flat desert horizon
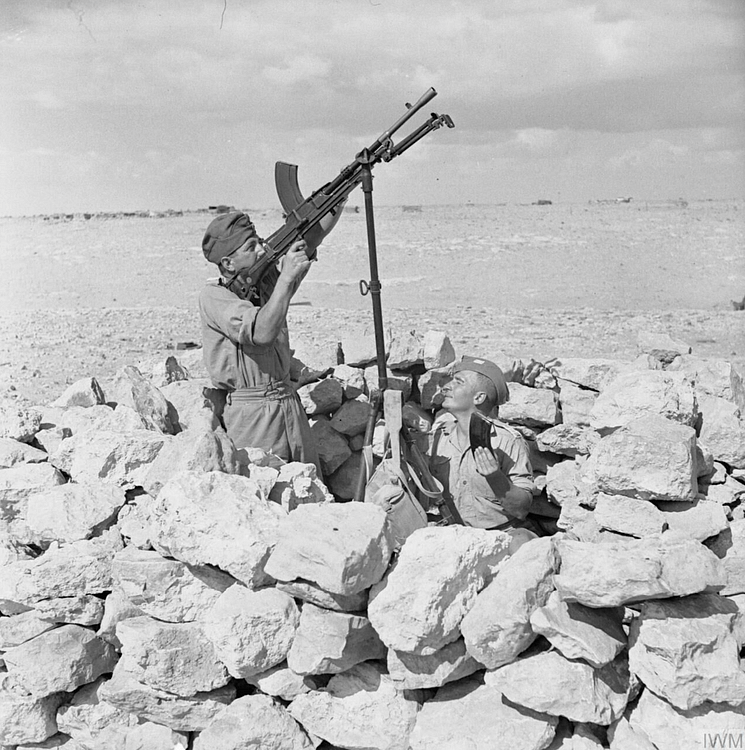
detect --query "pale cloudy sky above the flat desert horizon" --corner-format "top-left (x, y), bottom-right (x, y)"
top-left (0, 0), bottom-right (745, 216)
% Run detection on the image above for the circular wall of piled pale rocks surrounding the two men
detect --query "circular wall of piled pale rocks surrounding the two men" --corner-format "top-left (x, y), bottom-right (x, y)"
top-left (0, 331), bottom-right (745, 750)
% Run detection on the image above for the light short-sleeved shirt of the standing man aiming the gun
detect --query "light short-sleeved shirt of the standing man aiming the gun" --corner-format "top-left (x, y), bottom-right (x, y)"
top-left (199, 279), bottom-right (291, 391)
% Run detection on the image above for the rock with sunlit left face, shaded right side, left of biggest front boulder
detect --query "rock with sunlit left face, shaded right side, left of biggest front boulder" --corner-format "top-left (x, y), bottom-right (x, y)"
top-left (287, 603), bottom-right (386, 675)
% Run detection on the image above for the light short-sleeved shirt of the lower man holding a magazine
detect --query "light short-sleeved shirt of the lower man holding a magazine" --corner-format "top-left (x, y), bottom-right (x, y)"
top-left (429, 414), bottom-right (533, 529)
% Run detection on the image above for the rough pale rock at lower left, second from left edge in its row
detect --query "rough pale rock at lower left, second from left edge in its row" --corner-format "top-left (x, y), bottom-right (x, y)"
top-left (116, 616), bottom-right (230, 697)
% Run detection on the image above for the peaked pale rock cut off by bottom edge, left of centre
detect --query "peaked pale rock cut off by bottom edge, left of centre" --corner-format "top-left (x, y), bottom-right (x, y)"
top-left (194, 693), bottom-right (313, 750)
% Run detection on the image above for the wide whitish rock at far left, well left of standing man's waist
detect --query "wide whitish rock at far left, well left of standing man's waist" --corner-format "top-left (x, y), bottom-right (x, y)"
top-left (49, 427), bottom-right (167, 488)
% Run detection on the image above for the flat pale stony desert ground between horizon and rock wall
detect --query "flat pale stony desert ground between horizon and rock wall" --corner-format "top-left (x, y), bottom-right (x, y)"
top-left (0, 200), bottom-right (745, 403)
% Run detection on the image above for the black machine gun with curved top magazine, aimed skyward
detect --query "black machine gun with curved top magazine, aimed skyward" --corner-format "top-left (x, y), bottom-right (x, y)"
top-left (231, 88), bottom-right (455, 303)
